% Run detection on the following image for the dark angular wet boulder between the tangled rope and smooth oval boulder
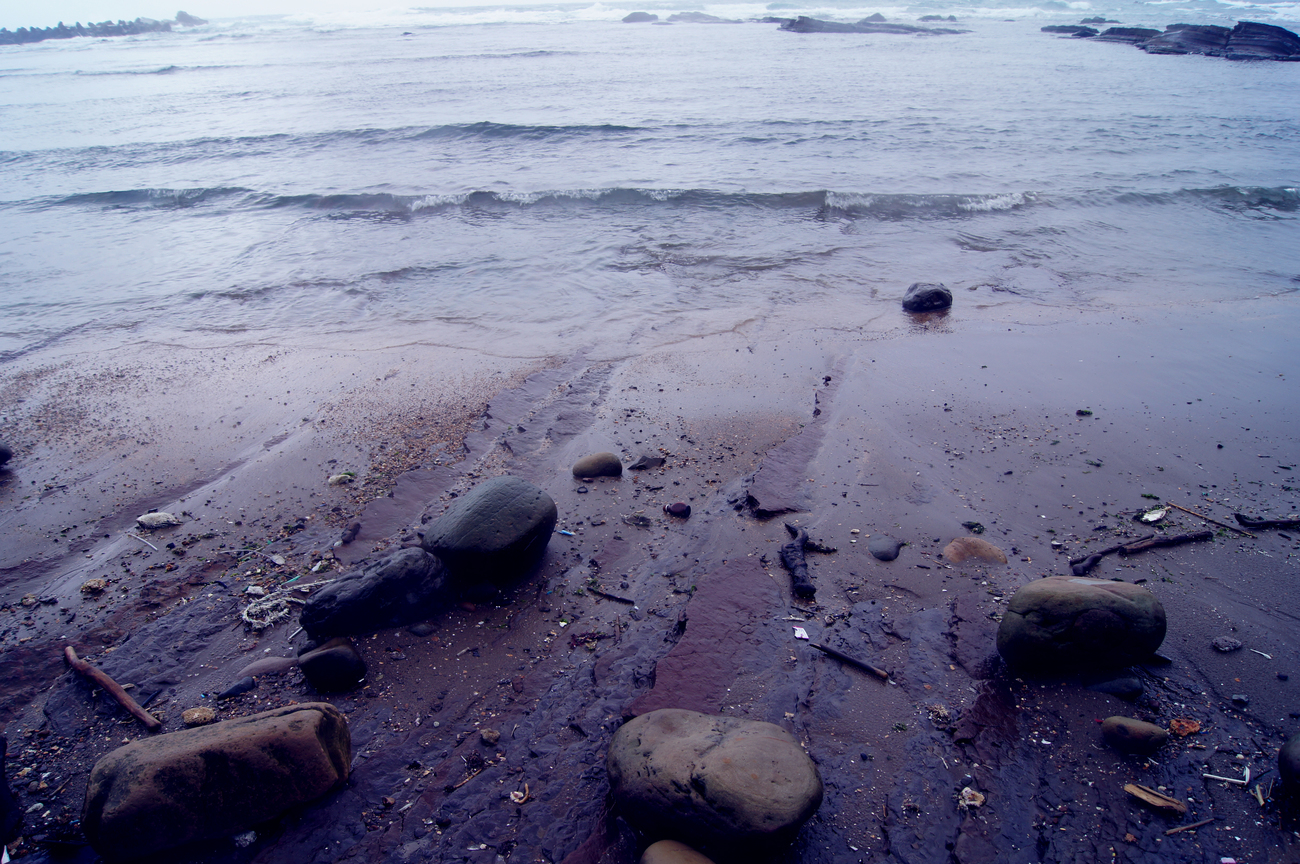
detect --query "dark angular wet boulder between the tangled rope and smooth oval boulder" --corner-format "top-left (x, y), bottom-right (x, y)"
top-left (298, 548), bottom-right (452, 639)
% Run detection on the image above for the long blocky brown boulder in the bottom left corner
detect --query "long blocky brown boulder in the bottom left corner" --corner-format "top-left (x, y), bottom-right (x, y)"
top-left (82, 702), bottom-right (352, 860)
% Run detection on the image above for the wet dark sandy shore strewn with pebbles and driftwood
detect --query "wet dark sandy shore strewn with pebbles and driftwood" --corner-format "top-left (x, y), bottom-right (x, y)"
top-left (0, 298), bottom-right (1300, 863)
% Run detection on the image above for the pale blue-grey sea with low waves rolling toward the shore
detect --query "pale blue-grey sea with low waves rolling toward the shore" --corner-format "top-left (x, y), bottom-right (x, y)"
top-left (0, 0), bottom-right (1300, 361)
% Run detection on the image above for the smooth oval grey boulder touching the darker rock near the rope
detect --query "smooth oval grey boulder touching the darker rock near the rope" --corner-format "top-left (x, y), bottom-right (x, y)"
top-left (424, 477), bottom-right (559, 586)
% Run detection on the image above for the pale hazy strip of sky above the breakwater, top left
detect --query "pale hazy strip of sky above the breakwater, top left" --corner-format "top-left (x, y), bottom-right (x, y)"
top-left (0, 0), bottom-right (501, 30)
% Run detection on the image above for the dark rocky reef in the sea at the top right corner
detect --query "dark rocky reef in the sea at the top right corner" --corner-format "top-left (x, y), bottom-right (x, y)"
top-left (1041, 21), bottom-right (1300, 61)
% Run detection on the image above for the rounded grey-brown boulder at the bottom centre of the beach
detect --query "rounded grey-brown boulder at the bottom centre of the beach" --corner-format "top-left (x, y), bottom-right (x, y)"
top-left (606, 708), bottom-right (822, 858)
